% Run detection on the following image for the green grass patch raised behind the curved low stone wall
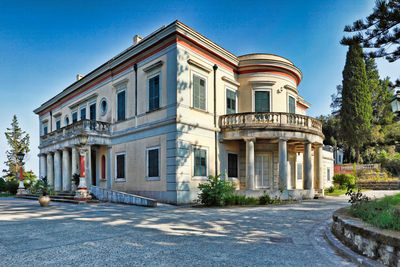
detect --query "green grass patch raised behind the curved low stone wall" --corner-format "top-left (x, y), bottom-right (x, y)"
top-left (350, 194), bottom-right (400, 231)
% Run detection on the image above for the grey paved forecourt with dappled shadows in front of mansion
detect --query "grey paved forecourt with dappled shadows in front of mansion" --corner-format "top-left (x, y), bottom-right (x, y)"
top-left (0, 192), bottom-right (398, 266)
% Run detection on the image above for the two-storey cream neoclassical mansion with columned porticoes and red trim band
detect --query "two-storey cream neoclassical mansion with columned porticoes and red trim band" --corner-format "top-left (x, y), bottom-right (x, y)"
top-left (34, 21), bottom-right (333, 204)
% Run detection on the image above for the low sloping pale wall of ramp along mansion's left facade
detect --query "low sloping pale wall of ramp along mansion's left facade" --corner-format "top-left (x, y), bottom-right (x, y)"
top-left (90, 185), bottom-right (157, 207)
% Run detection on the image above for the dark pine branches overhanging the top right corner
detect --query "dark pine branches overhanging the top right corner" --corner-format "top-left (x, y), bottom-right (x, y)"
top-left (341, 0), bottom-right (400, 62)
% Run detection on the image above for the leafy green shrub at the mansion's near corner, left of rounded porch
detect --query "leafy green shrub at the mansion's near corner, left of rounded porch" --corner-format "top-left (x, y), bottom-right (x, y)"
top-left (199, 175), bottom-right (235, 206)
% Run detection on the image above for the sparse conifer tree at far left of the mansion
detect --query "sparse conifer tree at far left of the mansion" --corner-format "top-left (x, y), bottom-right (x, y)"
top-left (3, 115), bottom-right (30, 180)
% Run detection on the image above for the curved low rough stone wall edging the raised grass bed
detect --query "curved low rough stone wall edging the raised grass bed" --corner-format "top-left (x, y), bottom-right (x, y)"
top-left (331, 208), bottom-right (400, 266)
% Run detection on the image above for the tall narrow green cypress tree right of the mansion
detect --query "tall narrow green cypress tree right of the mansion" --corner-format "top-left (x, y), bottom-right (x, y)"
top-left (340, 44), bottom-right (372, 163)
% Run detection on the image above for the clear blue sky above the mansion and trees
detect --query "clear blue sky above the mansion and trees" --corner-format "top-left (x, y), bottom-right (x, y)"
top-left (0, 0), bottom-right (400, 176)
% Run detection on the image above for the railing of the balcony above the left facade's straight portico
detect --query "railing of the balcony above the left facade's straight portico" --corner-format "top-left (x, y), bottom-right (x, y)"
top-left (40, 120), bottom-right (111, 145)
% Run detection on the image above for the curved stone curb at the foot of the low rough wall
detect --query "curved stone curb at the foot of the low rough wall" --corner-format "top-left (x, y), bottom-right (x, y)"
top-left (324, 222), bottom-right (385, 267)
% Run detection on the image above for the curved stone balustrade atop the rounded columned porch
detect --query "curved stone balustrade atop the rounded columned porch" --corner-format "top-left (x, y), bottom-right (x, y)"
top-left (219, 112), bottom-right (322, 135)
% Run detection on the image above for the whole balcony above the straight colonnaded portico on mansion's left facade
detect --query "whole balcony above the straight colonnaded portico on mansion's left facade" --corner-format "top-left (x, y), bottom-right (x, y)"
top-left (40, 120), bottom-right (111, 147)
